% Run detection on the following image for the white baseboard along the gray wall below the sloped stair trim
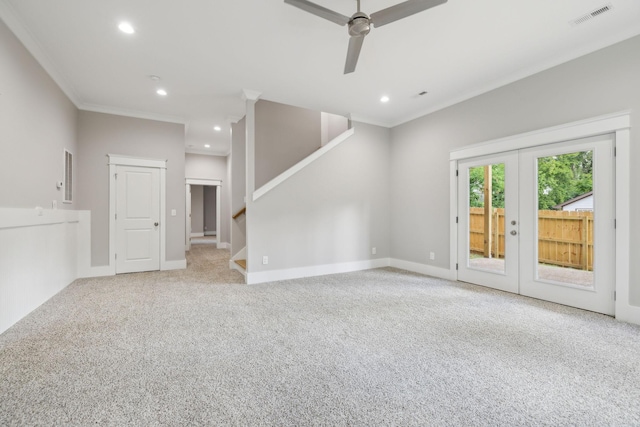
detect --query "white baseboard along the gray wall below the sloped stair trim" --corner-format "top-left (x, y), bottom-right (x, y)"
top-left (247, 258), bottom-right (390, 285)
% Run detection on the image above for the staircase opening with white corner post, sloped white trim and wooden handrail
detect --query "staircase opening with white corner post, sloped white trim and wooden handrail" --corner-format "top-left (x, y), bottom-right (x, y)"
top-left (229, 98), bottom-right (354, 281)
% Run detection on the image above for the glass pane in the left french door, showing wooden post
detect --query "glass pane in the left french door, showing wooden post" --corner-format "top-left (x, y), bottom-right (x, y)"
top-left (468, 163), bottom-right (505, 273)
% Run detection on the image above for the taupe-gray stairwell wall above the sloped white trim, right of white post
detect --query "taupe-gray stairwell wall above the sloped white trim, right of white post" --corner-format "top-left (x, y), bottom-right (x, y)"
top-left (255, 100), bottom-right (321, 189)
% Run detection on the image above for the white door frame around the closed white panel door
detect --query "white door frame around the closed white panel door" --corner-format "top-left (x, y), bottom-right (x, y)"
top-left (107, 154), bottom-right (168, 275)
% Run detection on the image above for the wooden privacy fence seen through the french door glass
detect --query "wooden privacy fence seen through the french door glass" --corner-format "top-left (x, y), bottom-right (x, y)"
top-left (469, 208), bottom-right (593, 270)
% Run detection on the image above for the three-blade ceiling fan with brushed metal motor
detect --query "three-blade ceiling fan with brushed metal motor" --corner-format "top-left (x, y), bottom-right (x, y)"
top-left (284, 0), bottom-right (447, 74)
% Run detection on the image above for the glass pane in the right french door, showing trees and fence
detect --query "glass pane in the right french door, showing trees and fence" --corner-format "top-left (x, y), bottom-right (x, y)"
top-left (537, 151), bottom-right (595, 287)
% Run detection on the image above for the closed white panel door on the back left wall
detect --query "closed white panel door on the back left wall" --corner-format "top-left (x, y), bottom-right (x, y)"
top-left (116, 166), bottom-right (160, 273)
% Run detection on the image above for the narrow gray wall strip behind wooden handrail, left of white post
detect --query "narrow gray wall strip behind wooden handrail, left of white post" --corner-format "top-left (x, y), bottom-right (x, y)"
top-left (230, 117), bottom-right (247, 256)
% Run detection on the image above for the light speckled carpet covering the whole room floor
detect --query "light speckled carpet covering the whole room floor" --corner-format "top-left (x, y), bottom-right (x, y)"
top-left (0, 245), bottom-right (640, 426)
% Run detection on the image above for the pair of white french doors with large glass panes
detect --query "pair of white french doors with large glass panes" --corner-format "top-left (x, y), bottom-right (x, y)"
top-left (458, 135), bottom-right (615, 315)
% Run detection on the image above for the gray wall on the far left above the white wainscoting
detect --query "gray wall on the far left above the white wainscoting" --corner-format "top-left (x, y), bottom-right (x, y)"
top-left (0, 21), bottom-right (79, 209)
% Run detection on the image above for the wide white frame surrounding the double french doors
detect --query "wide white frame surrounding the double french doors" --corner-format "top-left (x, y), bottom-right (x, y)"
top-left (449, 111), bottom-right (640, 324)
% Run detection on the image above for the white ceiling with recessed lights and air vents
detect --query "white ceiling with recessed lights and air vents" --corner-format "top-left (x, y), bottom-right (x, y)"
top-left (0, 0), bottom-right (640, 155)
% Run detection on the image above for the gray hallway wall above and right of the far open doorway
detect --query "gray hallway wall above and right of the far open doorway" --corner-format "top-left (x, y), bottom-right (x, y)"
top-left (185, 153), bottom-right (231, 243)
